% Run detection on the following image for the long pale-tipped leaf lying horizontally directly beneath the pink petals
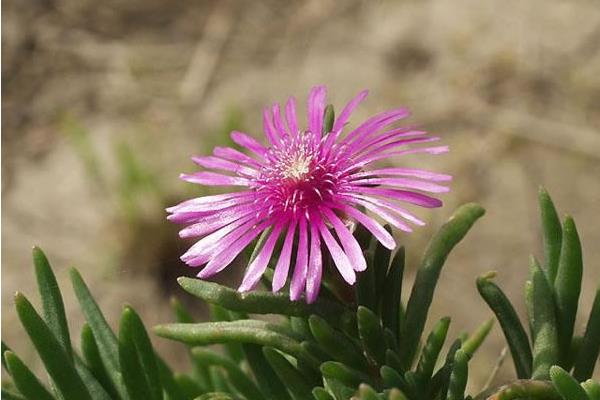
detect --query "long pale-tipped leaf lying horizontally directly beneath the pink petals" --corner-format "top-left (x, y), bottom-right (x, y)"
top-left (177, 277), bottom-right (346, 321)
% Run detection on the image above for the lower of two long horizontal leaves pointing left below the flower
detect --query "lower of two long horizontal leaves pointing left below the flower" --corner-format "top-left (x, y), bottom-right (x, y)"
top-left (154, 320), bottom-right (320, 368)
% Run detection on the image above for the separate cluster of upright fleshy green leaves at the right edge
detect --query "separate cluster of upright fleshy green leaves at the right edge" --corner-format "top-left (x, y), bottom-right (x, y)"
top-left (477, 188), bottom-right (600, 400)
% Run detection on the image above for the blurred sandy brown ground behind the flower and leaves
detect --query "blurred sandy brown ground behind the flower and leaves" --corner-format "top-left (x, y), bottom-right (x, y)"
top-left (2, 0), bottom-right (600, 390)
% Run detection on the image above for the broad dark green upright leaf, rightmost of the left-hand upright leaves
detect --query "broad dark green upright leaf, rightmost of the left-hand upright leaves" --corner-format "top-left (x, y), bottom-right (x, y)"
top-left (119, 306), bottom-right (163, 400)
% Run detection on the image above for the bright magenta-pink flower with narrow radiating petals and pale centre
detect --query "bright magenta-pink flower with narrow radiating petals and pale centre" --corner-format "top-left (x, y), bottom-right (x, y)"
top-left (167, 86), bottom-right (451, 303)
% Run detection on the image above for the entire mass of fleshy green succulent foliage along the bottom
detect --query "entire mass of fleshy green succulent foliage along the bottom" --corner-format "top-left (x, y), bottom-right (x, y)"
top-left (2, 192), bottom-right (600, 400)
